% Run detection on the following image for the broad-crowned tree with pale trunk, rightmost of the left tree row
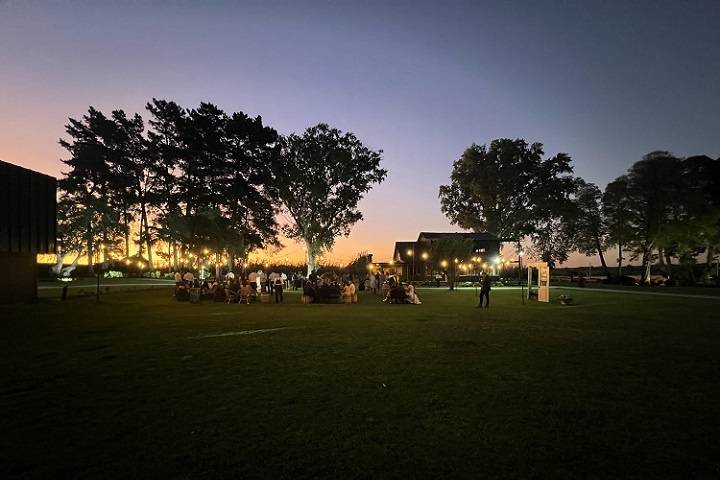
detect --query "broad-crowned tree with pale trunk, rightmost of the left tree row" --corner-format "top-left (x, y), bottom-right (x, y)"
top-left (272, 123), bottom-right (387, 273)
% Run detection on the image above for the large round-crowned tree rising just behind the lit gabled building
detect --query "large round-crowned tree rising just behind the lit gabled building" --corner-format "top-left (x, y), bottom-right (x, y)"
top-left (440, 138), bottom-right (575, 263)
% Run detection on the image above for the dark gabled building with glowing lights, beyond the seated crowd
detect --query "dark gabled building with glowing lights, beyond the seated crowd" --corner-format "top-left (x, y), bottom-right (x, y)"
top-left (393, 232), bottom-right (502, 279)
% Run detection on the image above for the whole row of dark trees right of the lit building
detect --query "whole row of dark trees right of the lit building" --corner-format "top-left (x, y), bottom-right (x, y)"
top-left (439, 139), bottom-right (720, 283)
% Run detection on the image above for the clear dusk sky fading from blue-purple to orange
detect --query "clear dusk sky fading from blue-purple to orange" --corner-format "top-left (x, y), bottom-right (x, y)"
top-left (0, 0), bottom-right (720, 265)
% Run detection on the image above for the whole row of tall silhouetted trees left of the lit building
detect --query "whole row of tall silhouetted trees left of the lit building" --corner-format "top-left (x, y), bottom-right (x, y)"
top-left (58, 99), bottom-right (387, 269)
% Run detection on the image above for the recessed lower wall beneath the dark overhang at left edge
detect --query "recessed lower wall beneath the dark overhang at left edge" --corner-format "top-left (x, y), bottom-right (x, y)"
top-left (0, 252), bottom-right (37, 303)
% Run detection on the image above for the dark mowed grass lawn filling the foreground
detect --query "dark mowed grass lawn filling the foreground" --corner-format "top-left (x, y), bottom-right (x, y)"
top-left (0, 289), bottom-right (720, 479)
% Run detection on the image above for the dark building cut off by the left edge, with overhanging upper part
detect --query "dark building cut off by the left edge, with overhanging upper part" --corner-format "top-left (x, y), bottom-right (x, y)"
top-left (0, 161), bottom-right (57, 303)
